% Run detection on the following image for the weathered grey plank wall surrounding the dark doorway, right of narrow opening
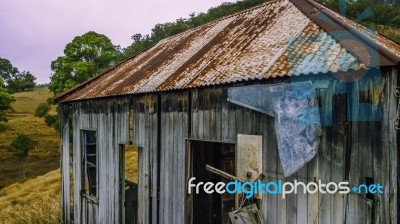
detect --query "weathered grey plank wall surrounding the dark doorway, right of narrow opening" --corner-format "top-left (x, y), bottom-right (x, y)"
top-left (133, 70), bottom-right (398, 224)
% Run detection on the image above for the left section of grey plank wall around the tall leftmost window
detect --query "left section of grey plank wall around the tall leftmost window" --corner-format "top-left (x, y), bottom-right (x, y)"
top-left (62, 97), bottom-right (129, 223)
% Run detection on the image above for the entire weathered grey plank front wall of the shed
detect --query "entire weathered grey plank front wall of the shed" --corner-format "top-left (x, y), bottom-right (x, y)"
top-left (63, 67), bottom-right (398, 224)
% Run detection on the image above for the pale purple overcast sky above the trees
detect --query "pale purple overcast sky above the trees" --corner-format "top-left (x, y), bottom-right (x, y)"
top-left (0, 0), bottom-right (236, 83)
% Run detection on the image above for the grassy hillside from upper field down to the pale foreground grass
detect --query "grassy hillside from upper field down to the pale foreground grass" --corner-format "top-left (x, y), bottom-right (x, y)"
top-left (0, 88), bottom-right (60, 190)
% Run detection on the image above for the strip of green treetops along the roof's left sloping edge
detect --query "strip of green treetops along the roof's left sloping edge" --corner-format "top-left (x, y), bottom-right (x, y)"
top-left (124, 0), bottom-right (267, 58)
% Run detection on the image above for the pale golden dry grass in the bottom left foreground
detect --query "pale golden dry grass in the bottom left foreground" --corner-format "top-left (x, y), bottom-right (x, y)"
top-left (0, 169), bottom-right (61, 224)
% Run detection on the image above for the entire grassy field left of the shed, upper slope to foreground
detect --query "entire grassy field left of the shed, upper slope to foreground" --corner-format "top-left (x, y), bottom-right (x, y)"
top-left (0, 88), bottom-right (60, 223)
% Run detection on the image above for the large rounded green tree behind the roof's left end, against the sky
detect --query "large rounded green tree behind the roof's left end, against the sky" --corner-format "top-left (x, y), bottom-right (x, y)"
top-left (49, 31), bottom-right (121, 94)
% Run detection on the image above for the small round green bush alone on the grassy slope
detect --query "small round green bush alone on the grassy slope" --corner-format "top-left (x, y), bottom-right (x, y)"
top-left (8, 134), bottom-right (36, 158)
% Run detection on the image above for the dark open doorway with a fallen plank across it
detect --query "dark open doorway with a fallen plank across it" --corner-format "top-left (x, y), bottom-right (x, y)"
top-left (191, 141), bottom-right (235, 224)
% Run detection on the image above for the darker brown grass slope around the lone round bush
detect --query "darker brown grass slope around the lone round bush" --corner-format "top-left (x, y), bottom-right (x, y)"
top-left (0, 114), bottom-right (60, 189)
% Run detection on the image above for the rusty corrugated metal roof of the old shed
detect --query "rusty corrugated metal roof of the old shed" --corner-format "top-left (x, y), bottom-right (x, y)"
top-left (57, 0), bottom-right (400, 102)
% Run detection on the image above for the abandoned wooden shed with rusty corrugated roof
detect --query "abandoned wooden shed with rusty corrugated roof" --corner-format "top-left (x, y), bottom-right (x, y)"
top-left (56, 0), bottom-right (400, 224)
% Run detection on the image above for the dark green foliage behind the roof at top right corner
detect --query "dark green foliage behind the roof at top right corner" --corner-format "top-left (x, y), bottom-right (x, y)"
top-left (320, 0), bottom-right (400, 28)
